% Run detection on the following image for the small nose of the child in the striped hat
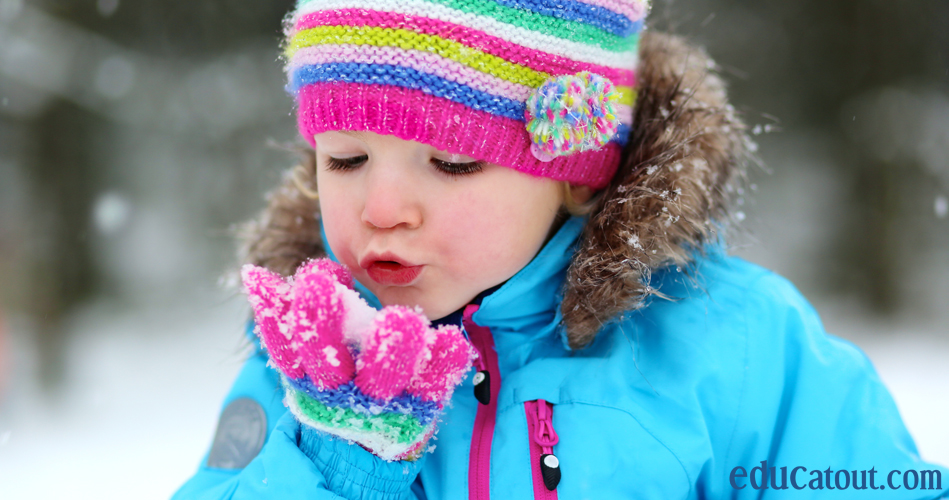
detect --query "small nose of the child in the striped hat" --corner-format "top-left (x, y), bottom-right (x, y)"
top-left (362, 164), bottom-right (422, 229)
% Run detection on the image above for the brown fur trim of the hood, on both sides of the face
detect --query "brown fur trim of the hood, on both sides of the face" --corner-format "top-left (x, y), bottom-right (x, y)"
top-left (235, 32), bottom-right (750, 348)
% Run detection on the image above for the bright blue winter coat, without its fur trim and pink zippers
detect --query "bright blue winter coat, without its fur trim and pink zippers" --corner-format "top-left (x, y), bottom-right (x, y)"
top-left (175, 218), bottom-right (949, 500)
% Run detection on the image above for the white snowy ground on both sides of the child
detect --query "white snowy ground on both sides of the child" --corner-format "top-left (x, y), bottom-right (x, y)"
top-left (0, 296), bottom-right (949, 500)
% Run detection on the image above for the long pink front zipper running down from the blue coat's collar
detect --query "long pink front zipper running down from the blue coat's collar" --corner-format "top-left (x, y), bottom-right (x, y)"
top-left (462, 304), bottom-right (501, 500)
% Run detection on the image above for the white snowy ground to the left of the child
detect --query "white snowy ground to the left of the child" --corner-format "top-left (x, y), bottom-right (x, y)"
top-left (0, 297), bottom-right (247, 500)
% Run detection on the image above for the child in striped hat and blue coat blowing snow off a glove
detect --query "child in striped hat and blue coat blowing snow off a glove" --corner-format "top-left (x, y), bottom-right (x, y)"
top-left (177, 0), bottom-right (949, 500)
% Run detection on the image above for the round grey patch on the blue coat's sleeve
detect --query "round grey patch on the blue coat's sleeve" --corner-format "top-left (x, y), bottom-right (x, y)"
top-left (208, 397), bottom-right (267, 469)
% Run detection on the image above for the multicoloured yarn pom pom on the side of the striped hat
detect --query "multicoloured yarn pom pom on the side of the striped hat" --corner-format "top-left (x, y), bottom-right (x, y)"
top-left (525, 71), bottom-right (620, 161)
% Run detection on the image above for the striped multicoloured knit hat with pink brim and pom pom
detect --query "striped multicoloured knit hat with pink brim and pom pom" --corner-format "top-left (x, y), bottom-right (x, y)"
top-left (285, 0), bottom-right (648, 188)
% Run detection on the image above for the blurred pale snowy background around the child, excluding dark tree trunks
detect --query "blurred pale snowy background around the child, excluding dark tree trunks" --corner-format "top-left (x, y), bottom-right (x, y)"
top-left (0, 0), bottom-right (949, 500)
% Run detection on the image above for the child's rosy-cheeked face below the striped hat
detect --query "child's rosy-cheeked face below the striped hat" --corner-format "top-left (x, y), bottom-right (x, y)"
top-left (316, 131), bottom-right (563, 319)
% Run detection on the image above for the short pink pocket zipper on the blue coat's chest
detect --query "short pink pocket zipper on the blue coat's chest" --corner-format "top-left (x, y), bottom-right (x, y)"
top-left (524, 399), bottom-right (560, 500)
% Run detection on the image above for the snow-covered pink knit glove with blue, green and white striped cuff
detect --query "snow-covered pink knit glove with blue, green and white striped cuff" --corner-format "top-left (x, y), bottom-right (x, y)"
top-left (241, 259), bottom-right (476, 461)
